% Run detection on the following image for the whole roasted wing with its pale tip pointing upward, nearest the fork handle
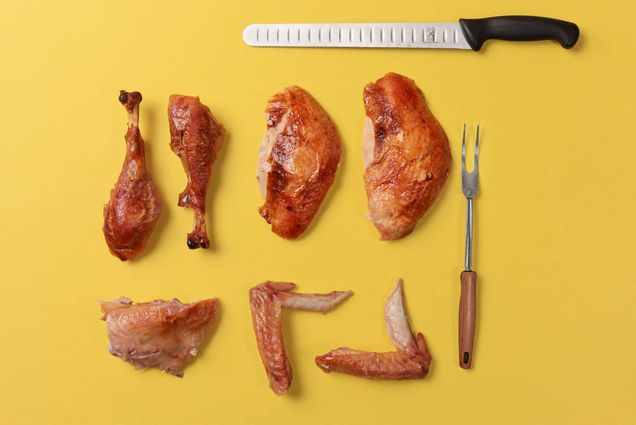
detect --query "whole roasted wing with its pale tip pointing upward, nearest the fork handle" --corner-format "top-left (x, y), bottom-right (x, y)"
top-left (316, 279), bottom-right (431, 380)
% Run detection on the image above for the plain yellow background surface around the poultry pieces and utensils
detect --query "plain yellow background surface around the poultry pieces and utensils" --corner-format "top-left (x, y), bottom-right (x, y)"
top-left (0, 0), bottom-right (636, 424)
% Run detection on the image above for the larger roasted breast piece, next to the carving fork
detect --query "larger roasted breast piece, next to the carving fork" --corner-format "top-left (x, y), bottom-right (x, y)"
top-left (363, 73), bottom-right (451, 240)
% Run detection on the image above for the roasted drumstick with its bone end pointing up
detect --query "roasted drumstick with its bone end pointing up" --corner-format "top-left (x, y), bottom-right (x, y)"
top-left (103, 90), bottom-right (163, 261)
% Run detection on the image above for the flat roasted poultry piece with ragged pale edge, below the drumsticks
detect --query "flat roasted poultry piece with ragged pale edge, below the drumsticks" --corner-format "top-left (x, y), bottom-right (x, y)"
top-left (100, 297), bottom-right (217, 377)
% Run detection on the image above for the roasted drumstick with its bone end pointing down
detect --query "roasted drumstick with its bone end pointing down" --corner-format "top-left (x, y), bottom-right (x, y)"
top-left (168, 95), bottom-right (225, 249)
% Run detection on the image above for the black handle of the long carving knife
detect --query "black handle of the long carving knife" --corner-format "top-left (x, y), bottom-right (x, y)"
top-left (459, 16), bottom-right (579, 52)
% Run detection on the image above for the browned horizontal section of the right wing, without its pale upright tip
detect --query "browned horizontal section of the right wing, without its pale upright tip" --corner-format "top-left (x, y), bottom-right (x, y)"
top-left (316, 333), bottom-right (431, 380)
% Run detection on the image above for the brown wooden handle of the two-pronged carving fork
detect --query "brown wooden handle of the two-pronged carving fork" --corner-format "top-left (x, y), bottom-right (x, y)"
top-left (459, 271), bottom-right (477, 369)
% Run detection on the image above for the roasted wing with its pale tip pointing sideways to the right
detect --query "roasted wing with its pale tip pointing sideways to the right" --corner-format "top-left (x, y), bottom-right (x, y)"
top-left (250, 281), bottom-right (352, 395)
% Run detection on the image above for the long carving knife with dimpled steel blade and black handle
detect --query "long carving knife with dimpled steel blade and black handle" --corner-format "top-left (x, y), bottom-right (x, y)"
top-left (243, 16), bottom-right (579, 51)
